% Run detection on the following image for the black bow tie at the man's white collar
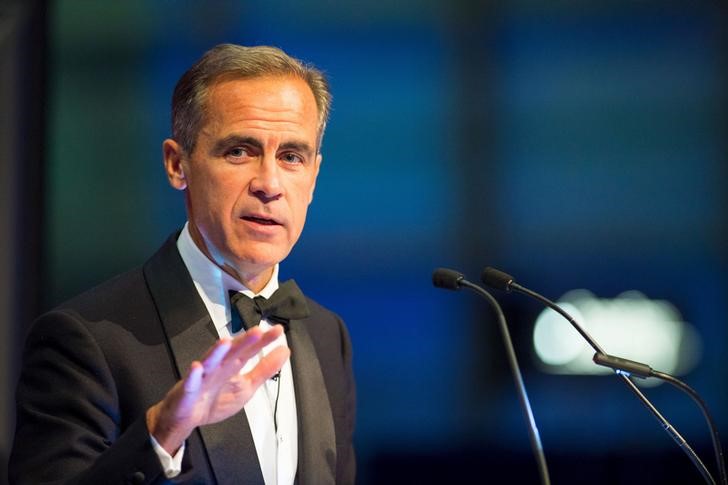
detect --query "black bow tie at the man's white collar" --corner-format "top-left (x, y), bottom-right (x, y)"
top-left (229, 280), bottom-right (311, 333)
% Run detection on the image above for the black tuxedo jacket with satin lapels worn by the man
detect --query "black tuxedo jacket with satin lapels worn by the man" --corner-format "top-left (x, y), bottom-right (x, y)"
top-left (9, 235), bottom-right (355, 485)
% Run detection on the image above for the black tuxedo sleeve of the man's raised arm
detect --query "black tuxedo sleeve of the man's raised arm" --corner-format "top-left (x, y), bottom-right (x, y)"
top-left (9, 311), bottom-right (165, 484)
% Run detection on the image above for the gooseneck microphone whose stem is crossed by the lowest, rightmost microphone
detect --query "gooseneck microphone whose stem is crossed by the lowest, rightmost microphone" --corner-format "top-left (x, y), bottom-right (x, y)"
top-left (481, 267), bottom-right (726, 485)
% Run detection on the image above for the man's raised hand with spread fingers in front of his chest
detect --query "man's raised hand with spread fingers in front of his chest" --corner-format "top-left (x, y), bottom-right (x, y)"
top-left (147, 325), bottom-right (290, 455)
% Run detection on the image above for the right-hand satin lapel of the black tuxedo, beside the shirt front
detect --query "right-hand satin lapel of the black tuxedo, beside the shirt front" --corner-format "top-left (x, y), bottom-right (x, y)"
top-left (287, 320), bottom-right (336, 485)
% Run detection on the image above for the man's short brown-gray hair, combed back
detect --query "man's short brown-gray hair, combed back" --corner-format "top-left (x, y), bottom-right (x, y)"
top-left (172, 44), bottom-right (331, 154)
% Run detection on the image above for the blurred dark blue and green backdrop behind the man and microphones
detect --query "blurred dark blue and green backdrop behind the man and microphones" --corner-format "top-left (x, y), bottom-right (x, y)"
top-left (0, 0), bottom-right (728, 484)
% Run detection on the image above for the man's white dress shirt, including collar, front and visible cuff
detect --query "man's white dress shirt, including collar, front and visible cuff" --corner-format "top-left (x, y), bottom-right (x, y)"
top-left (152, 224), bottom-right (298, 485)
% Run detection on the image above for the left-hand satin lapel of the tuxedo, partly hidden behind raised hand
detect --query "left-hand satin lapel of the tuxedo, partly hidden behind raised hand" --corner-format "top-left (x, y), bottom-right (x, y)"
top-left (144, 235), bottom-right (263, 485)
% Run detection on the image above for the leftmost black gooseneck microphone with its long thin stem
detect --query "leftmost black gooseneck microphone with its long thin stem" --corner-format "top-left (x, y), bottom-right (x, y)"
top-left (432, 268), bottom-right (551, 485)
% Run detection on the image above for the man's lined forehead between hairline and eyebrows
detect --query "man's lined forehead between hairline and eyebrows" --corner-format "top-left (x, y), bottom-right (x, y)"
top-left (202, 76), bottom-right (318, 139)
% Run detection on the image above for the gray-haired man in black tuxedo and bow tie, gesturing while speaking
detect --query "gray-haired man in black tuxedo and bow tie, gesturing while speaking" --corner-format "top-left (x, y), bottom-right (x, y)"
top-left (10, 45), bottom-right (355, 484)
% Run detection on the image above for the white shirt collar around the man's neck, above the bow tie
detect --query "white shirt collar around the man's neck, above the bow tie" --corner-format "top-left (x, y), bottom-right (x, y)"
top-left (177, 223), bottom-right (278, 329)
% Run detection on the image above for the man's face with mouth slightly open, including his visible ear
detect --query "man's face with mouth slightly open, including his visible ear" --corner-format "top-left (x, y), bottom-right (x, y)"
top-left (164, 77), bottom-right (321, 290)
